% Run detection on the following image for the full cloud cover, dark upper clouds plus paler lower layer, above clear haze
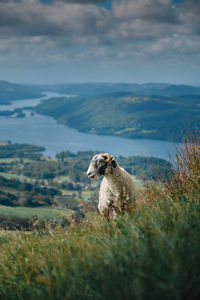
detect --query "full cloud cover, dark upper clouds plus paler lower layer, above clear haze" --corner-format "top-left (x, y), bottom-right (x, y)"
top-left (0, 0), bottom-right (200, 67)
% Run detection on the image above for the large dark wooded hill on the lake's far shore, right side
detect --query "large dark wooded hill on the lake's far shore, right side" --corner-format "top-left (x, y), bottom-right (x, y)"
top-left (35, 92), bottom-right (200, 141)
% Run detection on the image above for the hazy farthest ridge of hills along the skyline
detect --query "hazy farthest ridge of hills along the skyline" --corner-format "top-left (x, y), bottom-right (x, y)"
top-left (0, 80), bottom-right (200, 104)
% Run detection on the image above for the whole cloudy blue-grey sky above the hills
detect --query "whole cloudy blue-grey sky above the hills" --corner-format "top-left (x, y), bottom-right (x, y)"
top-left (0, 0), bottom-right (200, 85)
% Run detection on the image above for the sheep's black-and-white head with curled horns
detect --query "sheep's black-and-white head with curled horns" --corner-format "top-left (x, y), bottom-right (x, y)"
top-left (87, 153), bottom-right (117, 180)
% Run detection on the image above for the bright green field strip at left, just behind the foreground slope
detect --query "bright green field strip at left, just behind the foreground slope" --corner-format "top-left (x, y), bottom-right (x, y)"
top-left (0, 205), bottom-right (72, 220)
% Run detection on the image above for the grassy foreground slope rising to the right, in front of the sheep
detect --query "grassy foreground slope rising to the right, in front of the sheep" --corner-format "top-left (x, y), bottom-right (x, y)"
top-left (0, 134), bottom-right (200, 300)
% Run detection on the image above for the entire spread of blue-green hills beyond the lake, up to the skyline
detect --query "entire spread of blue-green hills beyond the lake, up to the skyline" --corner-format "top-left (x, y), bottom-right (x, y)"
top-left (0, 81), bottom-right (200, 142)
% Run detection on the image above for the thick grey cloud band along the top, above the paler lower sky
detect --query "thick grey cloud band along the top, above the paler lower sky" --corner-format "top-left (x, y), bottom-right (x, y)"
top-left (0, 0), bottom-right (200, 43)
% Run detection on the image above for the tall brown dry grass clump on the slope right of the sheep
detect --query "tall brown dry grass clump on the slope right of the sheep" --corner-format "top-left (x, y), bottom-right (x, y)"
top-left (138, 133), bottom-right (200, 206)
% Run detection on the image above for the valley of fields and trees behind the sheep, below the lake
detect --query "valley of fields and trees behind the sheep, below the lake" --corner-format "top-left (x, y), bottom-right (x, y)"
top-left (0, 142), bottom-right (171, 229)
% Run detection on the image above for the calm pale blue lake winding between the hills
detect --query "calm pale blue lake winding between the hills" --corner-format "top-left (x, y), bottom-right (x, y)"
top-left (0, 93), bottom-right (178, 159)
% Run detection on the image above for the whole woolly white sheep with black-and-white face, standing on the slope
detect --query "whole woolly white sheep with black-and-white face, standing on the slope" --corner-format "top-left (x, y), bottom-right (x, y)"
top-left (87, 153), bottom-right (135, 220)
